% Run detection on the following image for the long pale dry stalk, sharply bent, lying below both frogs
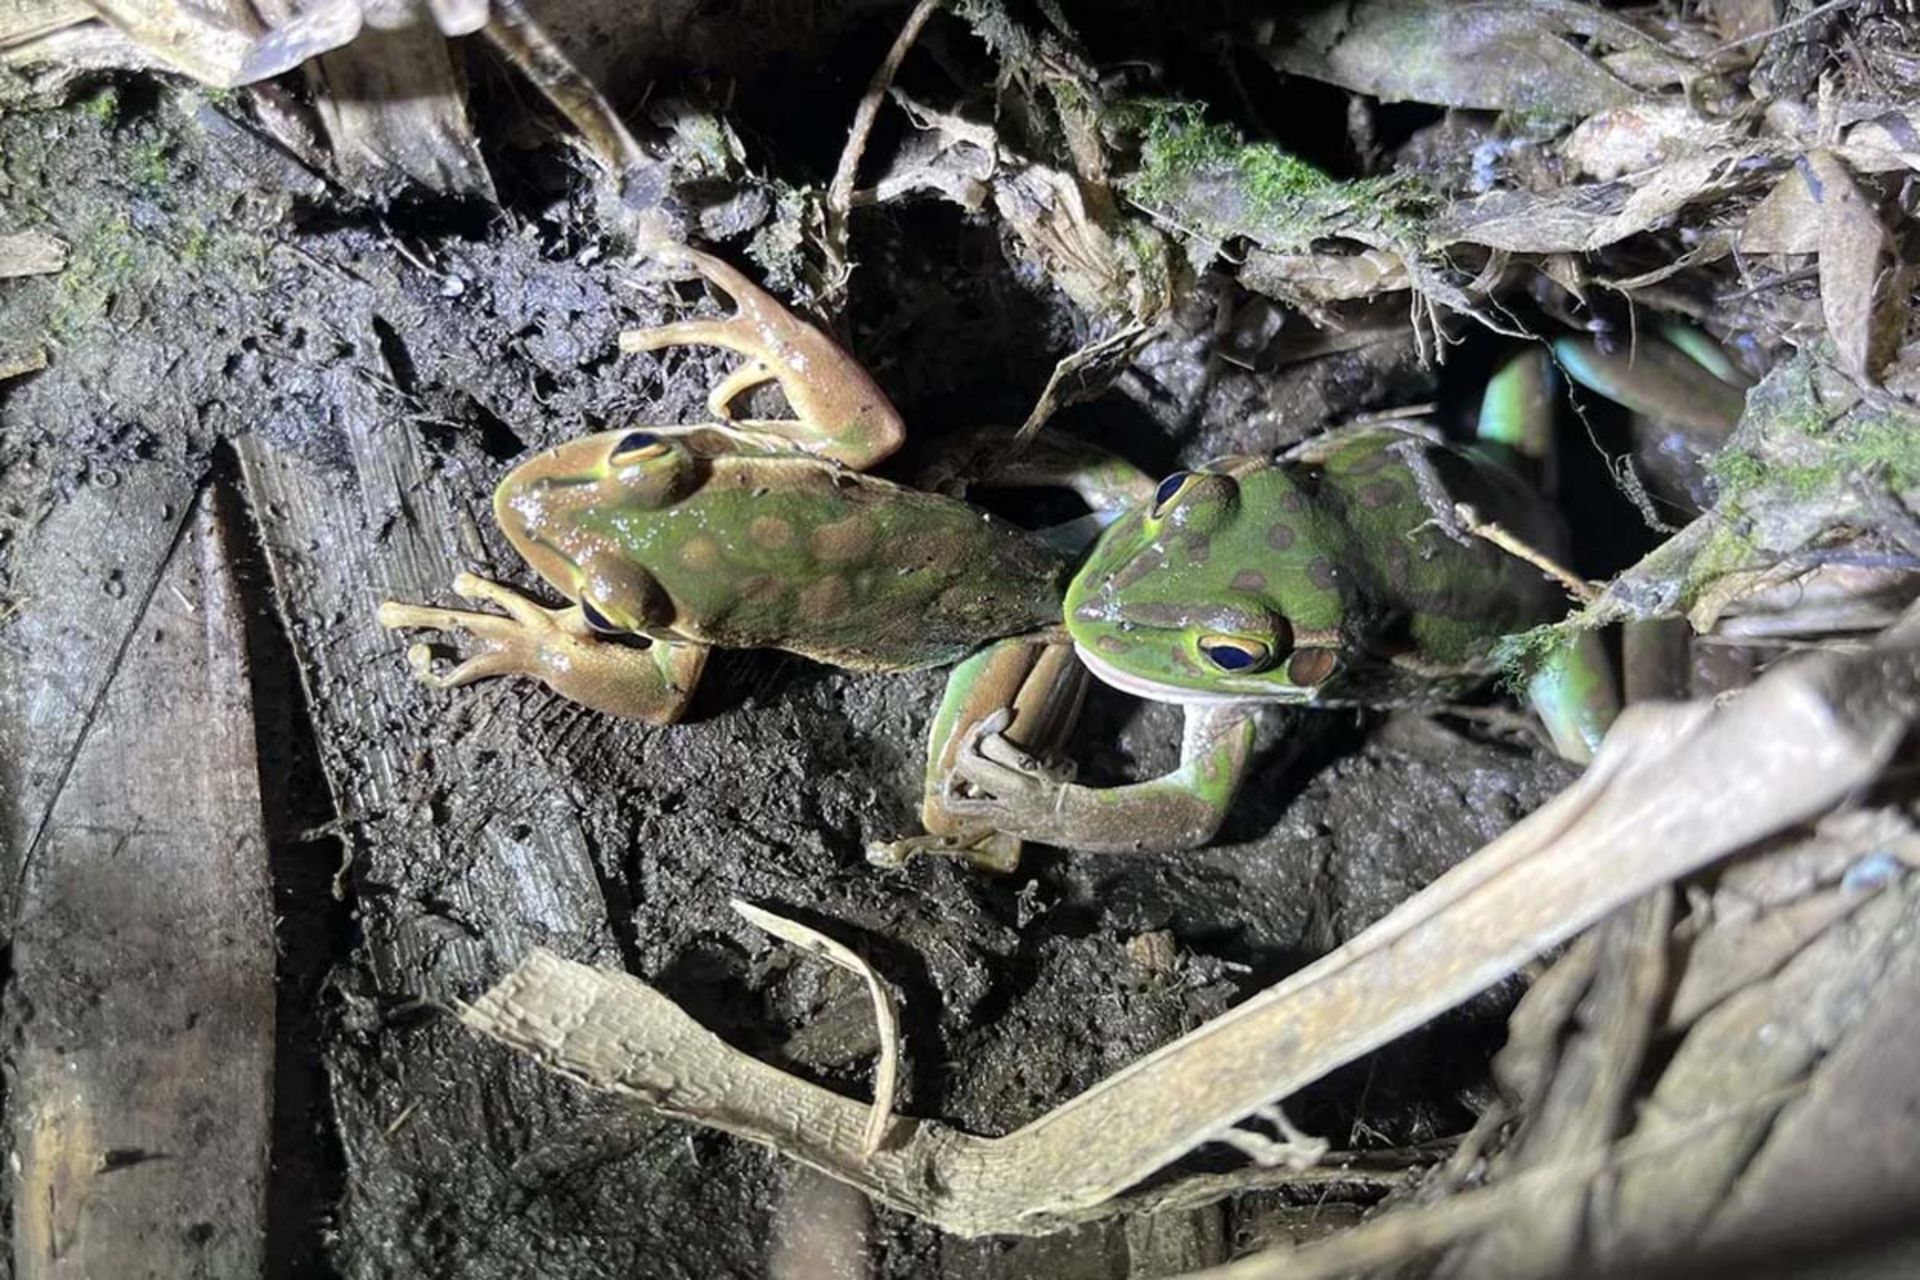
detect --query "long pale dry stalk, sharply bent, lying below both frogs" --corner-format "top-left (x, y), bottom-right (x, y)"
top-left (463, 610), bottom-right (1920, 1234)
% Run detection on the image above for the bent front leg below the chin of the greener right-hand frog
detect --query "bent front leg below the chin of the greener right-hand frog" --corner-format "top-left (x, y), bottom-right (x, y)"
top-left (945, 704), bottom-right (1254, 854)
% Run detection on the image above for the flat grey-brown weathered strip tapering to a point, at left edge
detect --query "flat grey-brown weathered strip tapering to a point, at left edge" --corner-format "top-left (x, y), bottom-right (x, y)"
top-left (12, 501), bottom-right (275, 1278)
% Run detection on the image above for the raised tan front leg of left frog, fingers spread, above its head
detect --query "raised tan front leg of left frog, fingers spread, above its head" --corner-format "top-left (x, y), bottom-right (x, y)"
top-left (620, 249), bottom-right (906, 470)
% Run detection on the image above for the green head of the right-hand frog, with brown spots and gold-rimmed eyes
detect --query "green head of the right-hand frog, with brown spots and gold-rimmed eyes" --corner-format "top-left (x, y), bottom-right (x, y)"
top-left (1066, 459), bottom-right (1348, 704)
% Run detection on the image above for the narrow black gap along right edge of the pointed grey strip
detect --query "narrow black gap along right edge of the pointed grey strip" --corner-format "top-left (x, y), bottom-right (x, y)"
top-left (213, 445), bottom-right (355, 1278)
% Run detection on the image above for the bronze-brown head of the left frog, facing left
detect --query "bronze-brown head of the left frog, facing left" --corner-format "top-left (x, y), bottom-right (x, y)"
top-left (493, 430), bottom-right (703, 631)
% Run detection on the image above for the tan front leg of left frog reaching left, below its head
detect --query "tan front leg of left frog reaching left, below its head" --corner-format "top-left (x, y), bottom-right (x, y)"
top-left (378, 574), bottom-right (707, 723)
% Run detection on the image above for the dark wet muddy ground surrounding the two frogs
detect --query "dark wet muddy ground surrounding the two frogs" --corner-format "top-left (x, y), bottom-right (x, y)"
top-left (0, 37), bottom-right (1571, 1278)
